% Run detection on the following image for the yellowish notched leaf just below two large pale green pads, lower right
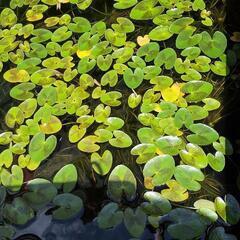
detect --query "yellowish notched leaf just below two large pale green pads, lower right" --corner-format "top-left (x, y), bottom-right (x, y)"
top-left (161, 179), bottom-right (189, 202)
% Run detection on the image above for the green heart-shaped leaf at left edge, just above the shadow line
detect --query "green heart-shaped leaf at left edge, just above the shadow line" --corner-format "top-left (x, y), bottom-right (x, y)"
top-left (0, 165), bottom-right (23, 192)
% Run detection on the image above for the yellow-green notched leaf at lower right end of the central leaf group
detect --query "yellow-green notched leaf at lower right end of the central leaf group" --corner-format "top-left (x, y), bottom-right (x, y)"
top-left (109, 130), bottom-right (132, 148)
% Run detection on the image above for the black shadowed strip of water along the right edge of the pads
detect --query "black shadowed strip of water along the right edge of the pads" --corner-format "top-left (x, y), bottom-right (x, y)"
top-left (220, 0), bottom-right (240, 237)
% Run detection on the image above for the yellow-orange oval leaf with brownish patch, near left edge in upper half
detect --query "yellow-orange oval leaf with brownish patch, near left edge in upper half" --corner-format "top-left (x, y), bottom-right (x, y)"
top-left (3, 68), bottom-right (30, 83)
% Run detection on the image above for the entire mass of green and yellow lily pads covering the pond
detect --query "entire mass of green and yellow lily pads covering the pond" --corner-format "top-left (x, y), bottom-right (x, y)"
top-left (0, 0), bottom-right (240, 240)
